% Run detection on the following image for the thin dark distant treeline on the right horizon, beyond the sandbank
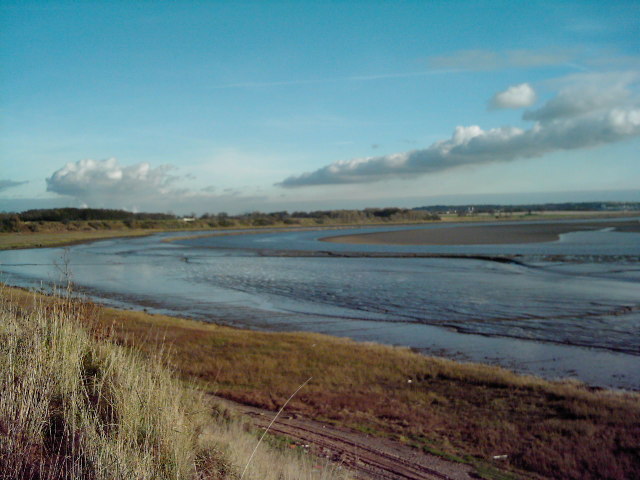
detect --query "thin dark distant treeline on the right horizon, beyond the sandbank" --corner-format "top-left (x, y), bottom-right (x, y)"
top-left (416, 202), bottom-right (640, 214)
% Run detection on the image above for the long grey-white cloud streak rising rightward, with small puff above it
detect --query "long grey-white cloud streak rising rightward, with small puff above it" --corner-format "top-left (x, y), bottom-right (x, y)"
top-left (277, 77), bottom-right (640, 187)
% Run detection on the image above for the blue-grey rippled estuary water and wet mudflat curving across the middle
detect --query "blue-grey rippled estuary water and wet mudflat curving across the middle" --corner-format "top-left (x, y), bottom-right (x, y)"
top-left (0, 218), bottom-right (640, 390)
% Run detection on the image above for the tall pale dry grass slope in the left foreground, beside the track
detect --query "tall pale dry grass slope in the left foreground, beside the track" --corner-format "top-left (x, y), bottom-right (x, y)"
top-left (0, 287), bottom-right (344, 480)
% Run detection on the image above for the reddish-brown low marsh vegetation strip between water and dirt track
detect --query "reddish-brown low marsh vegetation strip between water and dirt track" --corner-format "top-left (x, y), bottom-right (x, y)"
top-left (6, 291), bottom-right (640, 479)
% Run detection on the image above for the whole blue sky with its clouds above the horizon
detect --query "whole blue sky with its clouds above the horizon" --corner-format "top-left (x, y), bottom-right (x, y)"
top-left (0, 0), bottom-right (640, 213)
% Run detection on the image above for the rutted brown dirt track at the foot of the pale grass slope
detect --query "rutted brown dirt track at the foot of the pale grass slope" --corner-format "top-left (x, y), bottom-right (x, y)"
top-left (216, 397), bottom-right (479, 480)
